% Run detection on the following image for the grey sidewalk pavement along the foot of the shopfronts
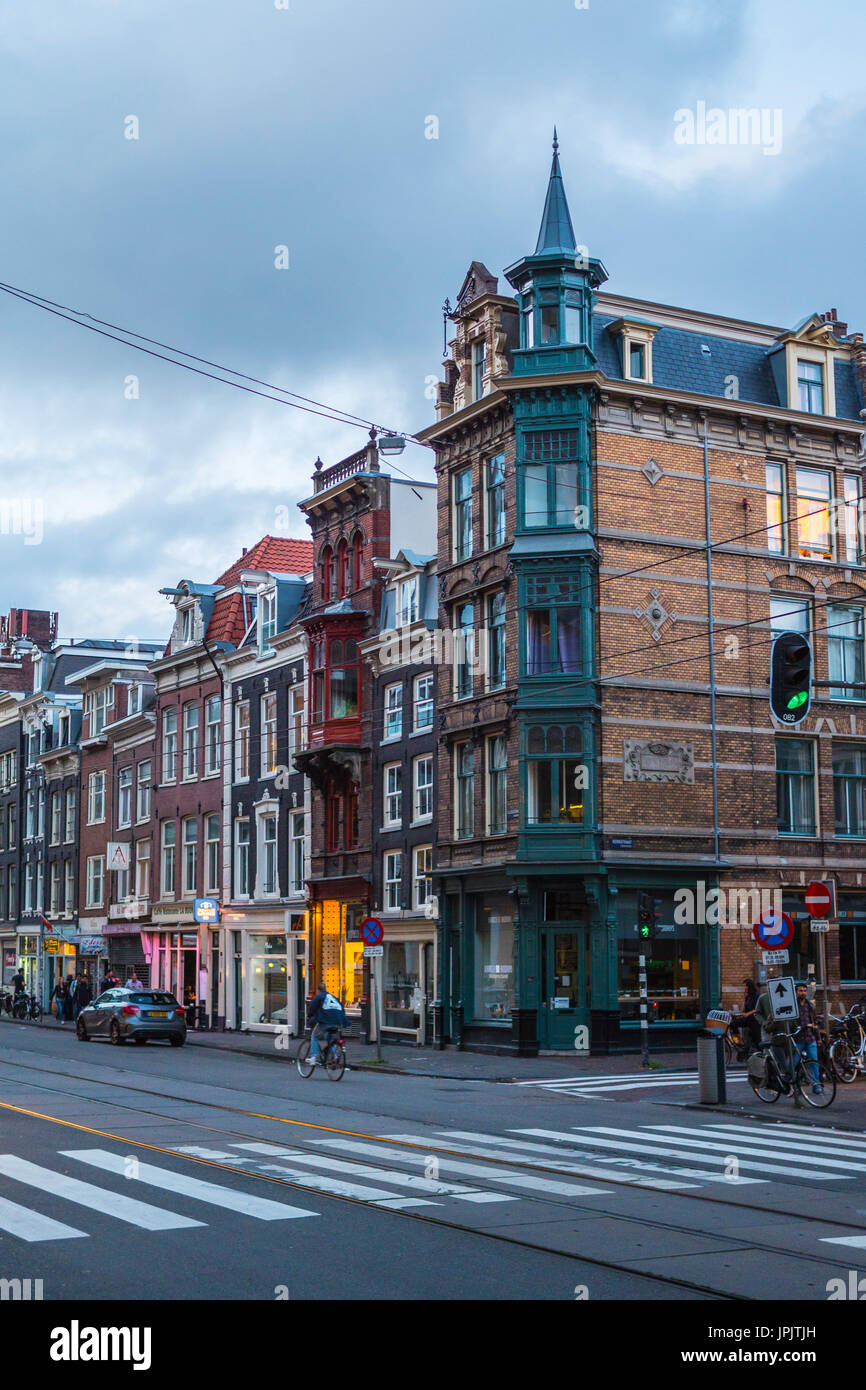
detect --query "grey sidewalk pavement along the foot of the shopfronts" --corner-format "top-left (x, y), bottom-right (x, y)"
top-left (186, 1029), bottom-right (695, 1081)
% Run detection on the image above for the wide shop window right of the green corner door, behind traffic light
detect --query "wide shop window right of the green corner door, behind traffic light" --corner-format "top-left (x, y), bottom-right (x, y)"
top-left (617, 890), bottom-right (701, 1027)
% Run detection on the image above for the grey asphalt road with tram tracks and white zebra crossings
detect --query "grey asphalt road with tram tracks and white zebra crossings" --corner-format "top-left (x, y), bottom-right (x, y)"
top-left (0, 1024), bottom-right (866, 1302)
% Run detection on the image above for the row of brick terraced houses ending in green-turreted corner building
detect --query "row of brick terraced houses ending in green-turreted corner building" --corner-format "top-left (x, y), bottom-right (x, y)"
top-left (0, 147), bottom-right (866, 1055)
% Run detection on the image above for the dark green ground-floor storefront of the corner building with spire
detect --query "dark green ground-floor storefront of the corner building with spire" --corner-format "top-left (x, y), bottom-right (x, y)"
top-left (439, 866), bottom-right (719, 1055)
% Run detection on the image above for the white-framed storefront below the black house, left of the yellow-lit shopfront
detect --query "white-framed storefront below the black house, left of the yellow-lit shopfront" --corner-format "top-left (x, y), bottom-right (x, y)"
top-left (222, 908), bottom-right (306, 1037)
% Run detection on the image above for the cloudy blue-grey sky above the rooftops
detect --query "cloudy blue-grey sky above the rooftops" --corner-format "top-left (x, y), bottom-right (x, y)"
top-left (0, 0), bottom-right (866, 638)
